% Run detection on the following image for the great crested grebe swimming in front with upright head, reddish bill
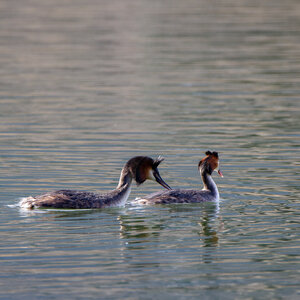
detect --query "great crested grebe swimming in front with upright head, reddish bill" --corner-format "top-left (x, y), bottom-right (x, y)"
top-left (136, 151), bottom-right (223, 204)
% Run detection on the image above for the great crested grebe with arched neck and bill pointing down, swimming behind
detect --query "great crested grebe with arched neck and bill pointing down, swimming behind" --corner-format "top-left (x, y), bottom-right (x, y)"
top-left (19, 156), bottom-right (171, 209)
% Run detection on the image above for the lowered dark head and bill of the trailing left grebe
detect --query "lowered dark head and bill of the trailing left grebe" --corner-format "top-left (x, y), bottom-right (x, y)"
top-left (127, 156), bottom-right (171, 190)
